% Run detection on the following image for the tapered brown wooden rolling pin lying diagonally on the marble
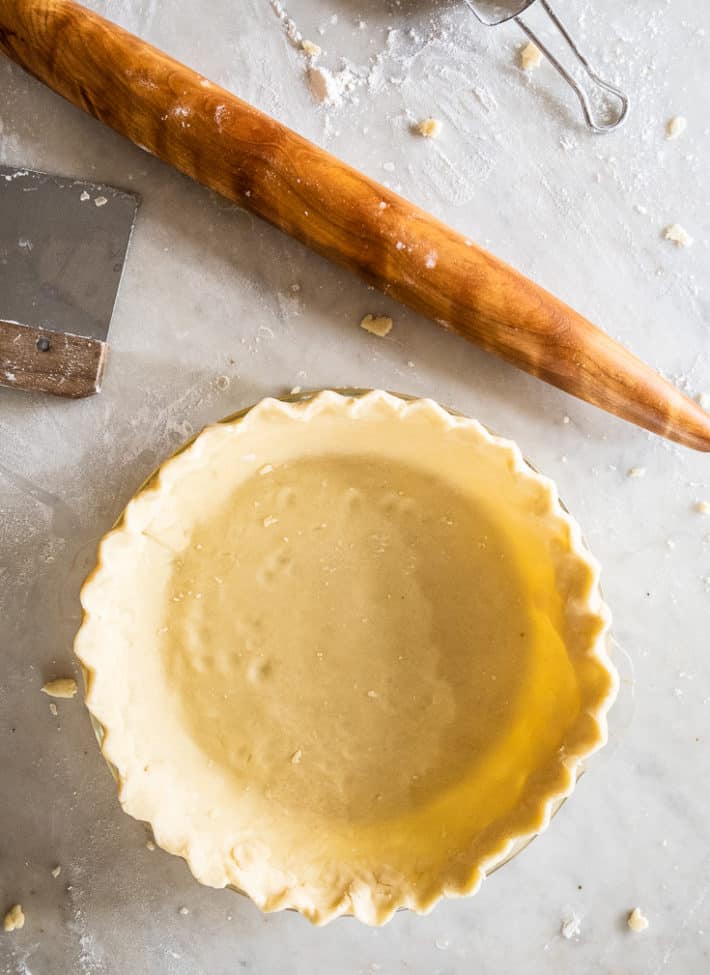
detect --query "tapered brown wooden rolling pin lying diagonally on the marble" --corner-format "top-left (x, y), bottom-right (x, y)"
top-left (0, 0), bottom-right (710, 450)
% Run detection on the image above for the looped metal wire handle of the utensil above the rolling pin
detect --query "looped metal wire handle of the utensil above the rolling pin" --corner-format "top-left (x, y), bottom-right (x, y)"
top-left (466, 0), bottom-right (629, 132)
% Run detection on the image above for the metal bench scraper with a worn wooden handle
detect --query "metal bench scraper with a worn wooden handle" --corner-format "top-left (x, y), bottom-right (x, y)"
top-left (0, 166), bottom-right (139, 398)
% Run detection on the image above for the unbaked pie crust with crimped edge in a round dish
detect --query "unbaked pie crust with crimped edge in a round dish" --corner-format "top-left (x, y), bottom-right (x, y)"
top-left (75, 391), bottom-right (617, 924)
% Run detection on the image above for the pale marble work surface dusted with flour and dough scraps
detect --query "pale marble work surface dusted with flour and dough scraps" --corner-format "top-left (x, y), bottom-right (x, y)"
top-left (0, 0), bottom-right (710, 975)
